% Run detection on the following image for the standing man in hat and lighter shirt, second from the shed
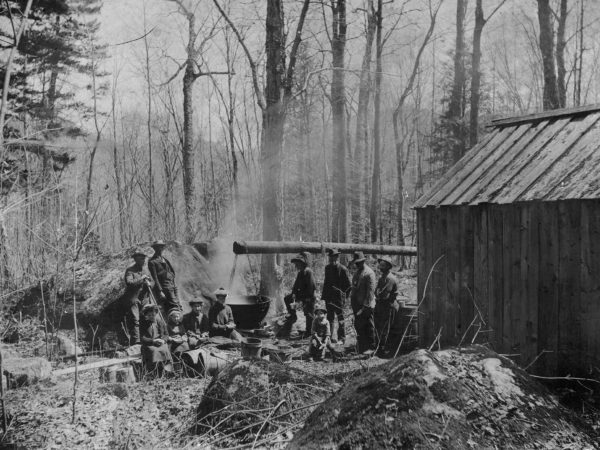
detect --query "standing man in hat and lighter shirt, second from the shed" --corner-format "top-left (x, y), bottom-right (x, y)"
top-left (350, 252), bottom-right (376, 353)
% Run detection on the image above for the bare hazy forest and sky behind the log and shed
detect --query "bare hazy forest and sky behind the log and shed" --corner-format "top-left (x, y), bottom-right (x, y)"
top-left (0, 0), bottom-right (600, 297)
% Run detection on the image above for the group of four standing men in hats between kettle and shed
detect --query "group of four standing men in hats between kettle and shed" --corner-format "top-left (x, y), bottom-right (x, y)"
top-left (279, 249), bottom-right (403, 357)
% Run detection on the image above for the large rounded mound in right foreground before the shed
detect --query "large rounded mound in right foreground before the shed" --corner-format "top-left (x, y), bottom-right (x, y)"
top-left (289, 347), bottom-right (598, 449)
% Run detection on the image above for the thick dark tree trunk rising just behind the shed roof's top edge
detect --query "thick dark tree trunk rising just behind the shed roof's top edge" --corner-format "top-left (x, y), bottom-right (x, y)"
top-left (538, 0), bottom-right (560, 110)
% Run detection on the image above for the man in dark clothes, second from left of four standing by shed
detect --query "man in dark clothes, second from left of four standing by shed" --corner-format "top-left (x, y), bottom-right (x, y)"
top-left (321, 248), bottom-right (350, 344)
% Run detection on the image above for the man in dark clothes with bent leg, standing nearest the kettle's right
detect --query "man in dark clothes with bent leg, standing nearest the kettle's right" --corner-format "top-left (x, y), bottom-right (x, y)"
top-left (284, 253), bottom-right (317, 337)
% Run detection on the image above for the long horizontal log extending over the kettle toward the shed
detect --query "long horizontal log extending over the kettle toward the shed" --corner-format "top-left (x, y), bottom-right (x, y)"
top-left (233, 241), bottom-right (417, 256)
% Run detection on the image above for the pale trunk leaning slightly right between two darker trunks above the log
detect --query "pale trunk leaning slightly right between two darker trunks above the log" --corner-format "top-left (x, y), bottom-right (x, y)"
top-left (350, 0), bottom-right (376, 242)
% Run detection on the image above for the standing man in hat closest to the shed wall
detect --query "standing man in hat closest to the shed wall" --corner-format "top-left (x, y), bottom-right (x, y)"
top-left (374, 256), bottom-right (402, 356)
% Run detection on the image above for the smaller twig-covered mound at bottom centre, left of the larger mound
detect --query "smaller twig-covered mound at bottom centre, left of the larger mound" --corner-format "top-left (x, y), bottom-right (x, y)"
top-left (195, 359), bottom-right (336, 448)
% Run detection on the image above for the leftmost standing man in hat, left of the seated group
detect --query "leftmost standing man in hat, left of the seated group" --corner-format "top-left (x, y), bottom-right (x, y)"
top-left (123, 248), bottom-right (154, 345)
